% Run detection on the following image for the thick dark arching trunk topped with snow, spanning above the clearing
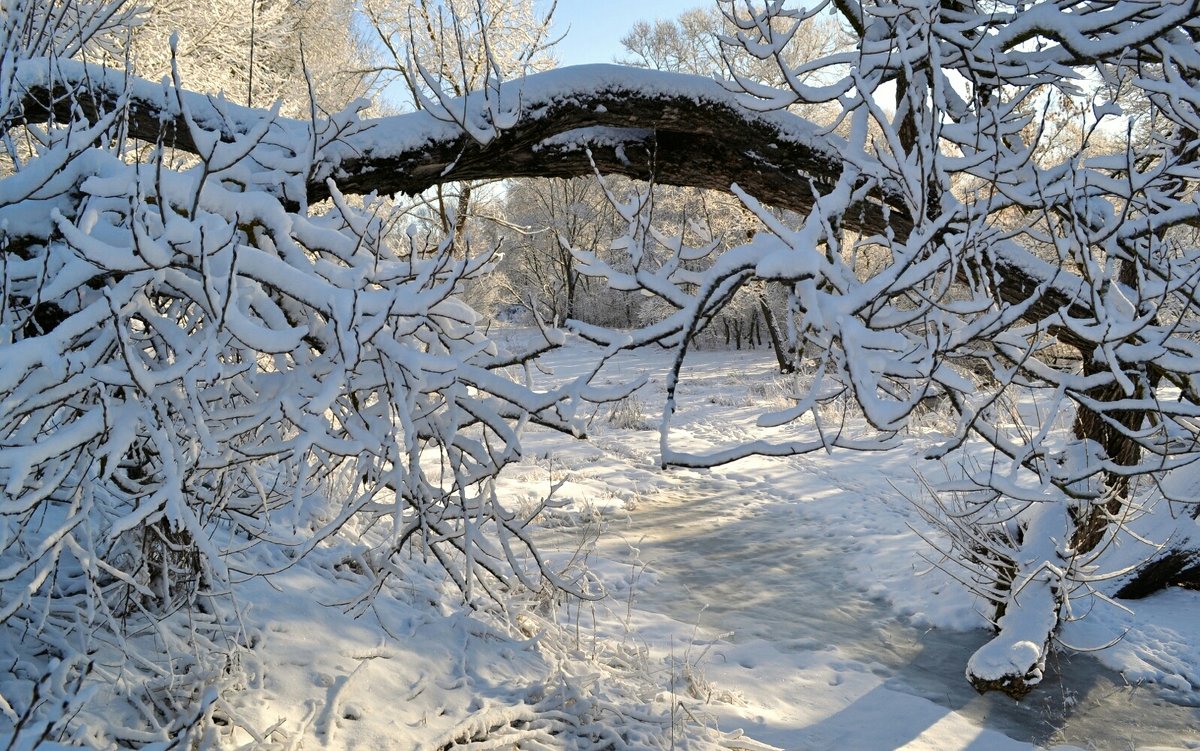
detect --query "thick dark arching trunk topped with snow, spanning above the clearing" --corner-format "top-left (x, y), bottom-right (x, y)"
top-left (4, 60), bottom-right (1104, 357)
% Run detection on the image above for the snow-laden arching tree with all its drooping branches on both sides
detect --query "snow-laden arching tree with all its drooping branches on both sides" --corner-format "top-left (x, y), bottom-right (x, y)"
top-left (7, 0), bottom-right (1200, 745)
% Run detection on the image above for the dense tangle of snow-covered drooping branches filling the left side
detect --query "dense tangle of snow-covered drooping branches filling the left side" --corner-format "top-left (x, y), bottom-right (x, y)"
top-left (0, 42), bottom-right (604, 746)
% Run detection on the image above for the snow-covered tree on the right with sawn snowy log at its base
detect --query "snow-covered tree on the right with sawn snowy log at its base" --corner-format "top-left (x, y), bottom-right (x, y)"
top-left (568, 0), bottom-right (1200, 696)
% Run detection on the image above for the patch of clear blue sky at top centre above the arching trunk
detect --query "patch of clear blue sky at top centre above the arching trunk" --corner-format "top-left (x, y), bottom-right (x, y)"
top-left (542, 0), bottom-right (712, 65)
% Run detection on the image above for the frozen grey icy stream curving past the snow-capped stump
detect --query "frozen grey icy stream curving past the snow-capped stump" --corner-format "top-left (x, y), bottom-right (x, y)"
top-left (588, 459), bottom-right (1198, 749)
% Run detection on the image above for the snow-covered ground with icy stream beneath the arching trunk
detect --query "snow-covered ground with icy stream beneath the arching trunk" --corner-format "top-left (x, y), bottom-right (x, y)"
top-left (199, 335), bottom-right (1200, 750)
